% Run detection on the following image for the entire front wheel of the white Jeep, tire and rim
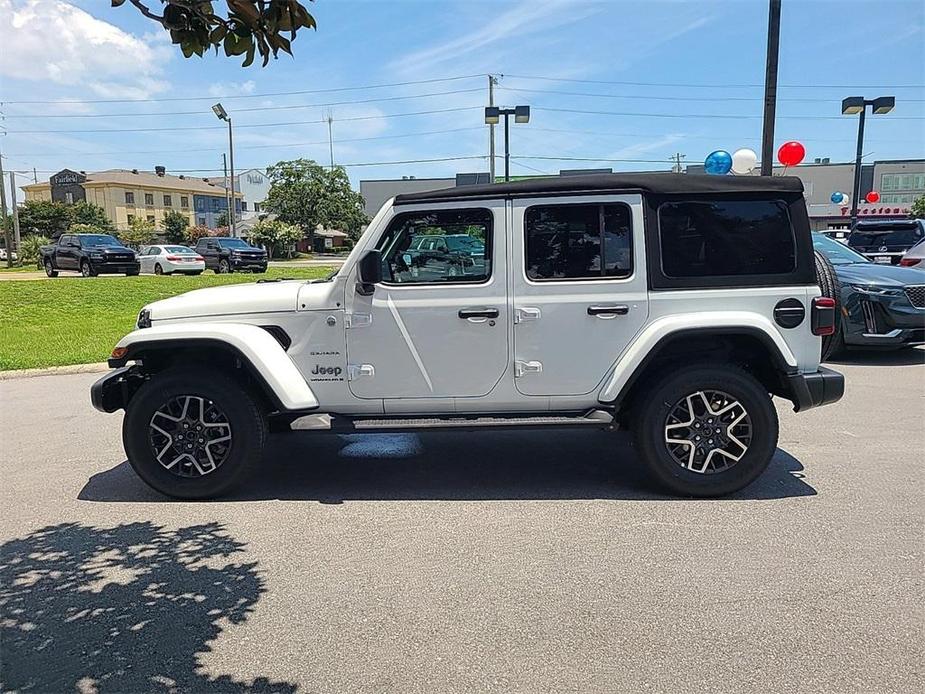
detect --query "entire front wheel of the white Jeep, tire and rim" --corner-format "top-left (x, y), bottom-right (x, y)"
top-left (122, 369), bottom-right (267, 499)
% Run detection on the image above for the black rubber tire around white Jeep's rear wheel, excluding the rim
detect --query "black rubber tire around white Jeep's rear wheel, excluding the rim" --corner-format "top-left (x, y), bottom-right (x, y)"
top-left (633, 364), bottom-right (778, 497)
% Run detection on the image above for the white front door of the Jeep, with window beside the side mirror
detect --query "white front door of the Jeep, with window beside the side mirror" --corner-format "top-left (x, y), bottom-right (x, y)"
top-left (347, 201), bottom-right (509, 399)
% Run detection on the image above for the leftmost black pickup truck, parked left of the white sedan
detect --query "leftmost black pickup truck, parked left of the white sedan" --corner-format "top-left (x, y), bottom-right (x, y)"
top-left (39, 234), bottom-right (140, 277)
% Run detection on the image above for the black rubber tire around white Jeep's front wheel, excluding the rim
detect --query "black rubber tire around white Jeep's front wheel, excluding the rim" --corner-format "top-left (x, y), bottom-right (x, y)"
top-left (122, 368), bottom-right (267, 499)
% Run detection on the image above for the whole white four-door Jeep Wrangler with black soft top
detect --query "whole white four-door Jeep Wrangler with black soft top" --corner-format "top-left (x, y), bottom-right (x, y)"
top-left (91, 174), bottom-right (844, 498)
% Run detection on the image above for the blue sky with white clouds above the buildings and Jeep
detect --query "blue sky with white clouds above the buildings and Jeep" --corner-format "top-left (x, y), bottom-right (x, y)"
top-left (0, 0), bottom-right (925, 207)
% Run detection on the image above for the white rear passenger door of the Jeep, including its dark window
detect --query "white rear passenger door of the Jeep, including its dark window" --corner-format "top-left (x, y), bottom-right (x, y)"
top-left (511, 195), bottom-right (648, 396)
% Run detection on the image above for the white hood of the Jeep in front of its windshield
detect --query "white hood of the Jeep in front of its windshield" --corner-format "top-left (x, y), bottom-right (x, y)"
top-left (145, 280), bottom-right (335, 322)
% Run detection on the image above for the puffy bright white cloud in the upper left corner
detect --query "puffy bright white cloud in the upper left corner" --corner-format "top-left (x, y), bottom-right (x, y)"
top-left (0, 0), bottom-right (172, 99)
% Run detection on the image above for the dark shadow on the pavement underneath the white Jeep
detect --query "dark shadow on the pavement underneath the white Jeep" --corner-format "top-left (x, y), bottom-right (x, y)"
top-left (78, 431), bottom-right (816, 504)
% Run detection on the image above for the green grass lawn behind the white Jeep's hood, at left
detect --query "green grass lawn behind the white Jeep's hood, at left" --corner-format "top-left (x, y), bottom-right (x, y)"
top-left (0, 268), bottom-right (331, 370)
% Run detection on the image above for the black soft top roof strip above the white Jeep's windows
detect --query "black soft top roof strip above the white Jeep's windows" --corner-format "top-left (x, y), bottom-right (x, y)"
top-left (395, 173), bottom-right (803, 205)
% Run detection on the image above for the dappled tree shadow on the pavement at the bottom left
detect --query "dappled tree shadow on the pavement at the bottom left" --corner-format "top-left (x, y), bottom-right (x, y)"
top-left (0, 522), bottom-right (296, 692)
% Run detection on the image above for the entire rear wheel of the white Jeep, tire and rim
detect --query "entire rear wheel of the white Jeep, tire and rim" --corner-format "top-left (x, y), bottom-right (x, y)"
top-left (635, 365), bottom-right (778, 497)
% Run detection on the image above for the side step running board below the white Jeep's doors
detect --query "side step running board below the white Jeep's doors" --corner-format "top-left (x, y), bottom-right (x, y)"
top-left (292, 410), bottom-right (617, 433)
